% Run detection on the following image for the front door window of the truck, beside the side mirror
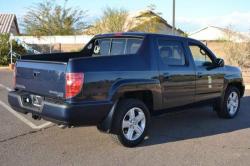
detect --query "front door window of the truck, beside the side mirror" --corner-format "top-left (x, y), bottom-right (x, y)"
top-left (189, 44), bottom-right (212, 66)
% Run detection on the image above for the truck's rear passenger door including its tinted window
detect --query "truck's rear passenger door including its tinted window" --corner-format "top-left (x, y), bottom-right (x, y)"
top-left (157, 38), bottom-right (195, 108)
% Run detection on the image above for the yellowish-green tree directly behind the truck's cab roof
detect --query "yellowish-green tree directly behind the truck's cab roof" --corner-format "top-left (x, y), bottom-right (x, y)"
top-left (86, 7), bottom-right (128, 35)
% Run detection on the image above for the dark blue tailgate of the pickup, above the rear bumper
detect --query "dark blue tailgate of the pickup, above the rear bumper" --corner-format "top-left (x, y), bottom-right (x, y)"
top-left (16, 60), bottom-right (67, 98)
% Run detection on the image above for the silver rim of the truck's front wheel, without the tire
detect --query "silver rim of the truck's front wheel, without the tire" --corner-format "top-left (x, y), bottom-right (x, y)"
top-left (227, 92), bottom-right (239, 115)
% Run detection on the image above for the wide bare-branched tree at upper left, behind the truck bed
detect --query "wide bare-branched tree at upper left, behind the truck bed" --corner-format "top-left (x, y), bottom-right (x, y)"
top-left (23, 0), bottom-right (86, 36)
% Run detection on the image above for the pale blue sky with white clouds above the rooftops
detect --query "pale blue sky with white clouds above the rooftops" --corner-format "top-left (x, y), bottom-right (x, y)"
top-left (0, 0), bottom-right (250, 32)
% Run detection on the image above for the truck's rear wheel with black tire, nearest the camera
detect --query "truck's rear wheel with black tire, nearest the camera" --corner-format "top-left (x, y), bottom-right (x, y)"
top-left (112, 99), bottom-right (150, 147)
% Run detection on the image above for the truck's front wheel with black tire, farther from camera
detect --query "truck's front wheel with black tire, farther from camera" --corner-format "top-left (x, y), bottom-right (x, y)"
top-left (215, 86), bottom-right (240, 119)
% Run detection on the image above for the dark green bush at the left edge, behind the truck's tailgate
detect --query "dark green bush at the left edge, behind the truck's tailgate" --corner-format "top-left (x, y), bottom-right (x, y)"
top-left (0, 34), bottom-right (26, 65)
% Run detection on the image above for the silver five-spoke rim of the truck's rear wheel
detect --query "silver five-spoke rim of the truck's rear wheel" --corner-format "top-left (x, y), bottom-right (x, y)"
top-left (122, 107), bottom-right (146, 141)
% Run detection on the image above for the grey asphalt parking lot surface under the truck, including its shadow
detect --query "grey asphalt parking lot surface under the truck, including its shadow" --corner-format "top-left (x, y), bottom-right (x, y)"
top-left (0, 70), bottom-right (250, 166)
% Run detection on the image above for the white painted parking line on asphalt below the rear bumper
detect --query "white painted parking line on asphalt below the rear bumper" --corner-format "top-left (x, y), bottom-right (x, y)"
top-left (0, 100), bottom-right (52, 130)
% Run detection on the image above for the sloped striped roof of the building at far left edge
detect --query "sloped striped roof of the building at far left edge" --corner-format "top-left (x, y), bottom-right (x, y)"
top-left (0, 14), bottom-right (20, 35)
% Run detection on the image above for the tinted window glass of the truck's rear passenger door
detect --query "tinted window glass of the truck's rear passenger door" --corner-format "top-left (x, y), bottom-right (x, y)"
top-left (158, 39), bottom-right (186, 66)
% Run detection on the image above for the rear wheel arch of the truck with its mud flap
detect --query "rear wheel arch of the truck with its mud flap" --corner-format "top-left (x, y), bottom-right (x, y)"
top-left (97, 81), bottom-right (162, 133)
